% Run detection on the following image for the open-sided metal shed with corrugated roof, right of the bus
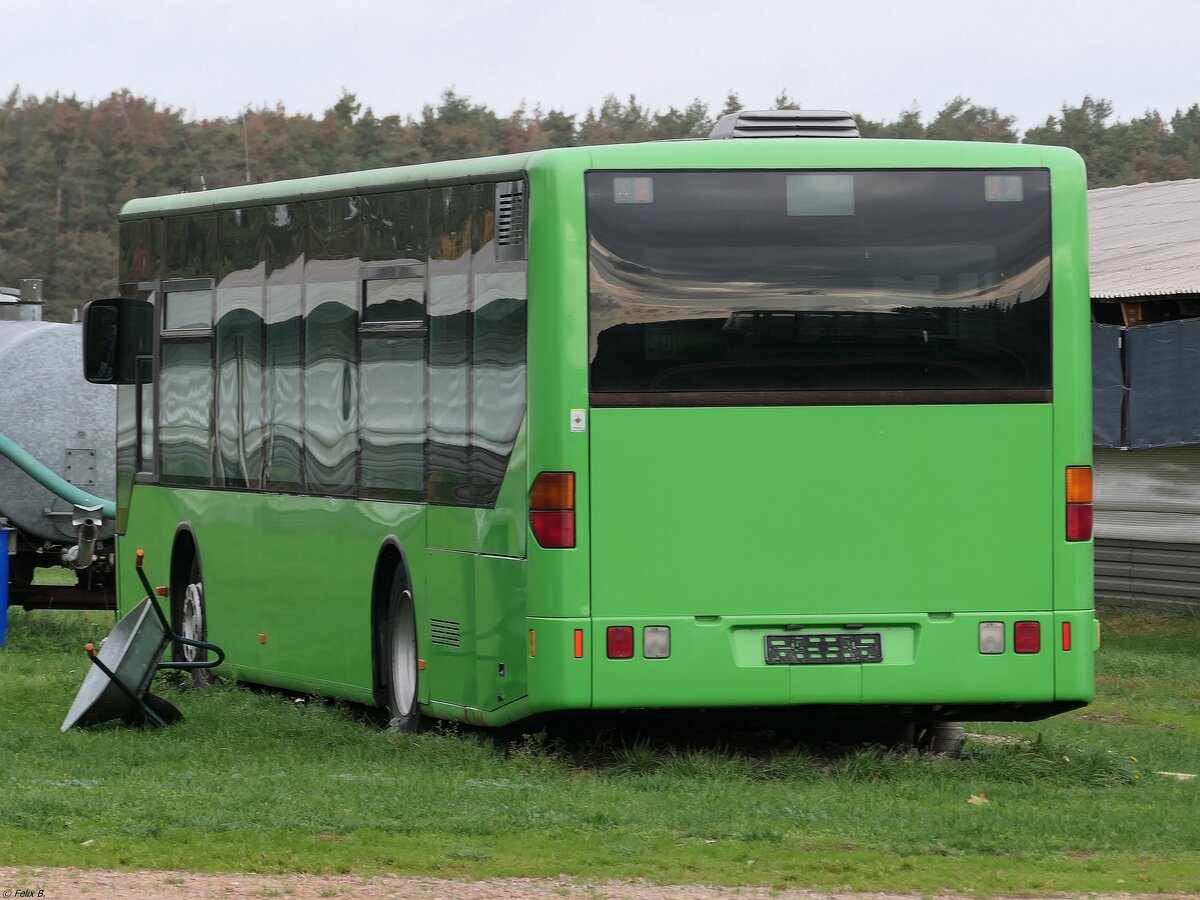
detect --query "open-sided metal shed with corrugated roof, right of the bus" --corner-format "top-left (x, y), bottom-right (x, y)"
top-left (1088, 179), bottom-right (1200, 605)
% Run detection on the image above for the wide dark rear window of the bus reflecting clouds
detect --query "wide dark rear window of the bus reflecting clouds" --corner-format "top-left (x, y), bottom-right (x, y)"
top-left (587, 169), bottom-right (1051, 406)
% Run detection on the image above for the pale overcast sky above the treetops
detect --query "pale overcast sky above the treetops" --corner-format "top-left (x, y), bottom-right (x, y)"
top-left (0, 0), bottom-right (1200, 130)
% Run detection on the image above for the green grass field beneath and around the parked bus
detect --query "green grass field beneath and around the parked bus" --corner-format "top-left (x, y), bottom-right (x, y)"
top-left (0, 595), bottom-right (1200, 896)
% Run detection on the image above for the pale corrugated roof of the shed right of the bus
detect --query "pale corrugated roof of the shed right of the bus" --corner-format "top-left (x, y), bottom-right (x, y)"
top-left (1087, 179), bottom-right (1200, 300)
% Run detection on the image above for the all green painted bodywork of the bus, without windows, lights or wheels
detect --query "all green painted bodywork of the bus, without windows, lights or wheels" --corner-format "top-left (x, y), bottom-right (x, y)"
top-left (120, 140), bottom-right (1094, 724)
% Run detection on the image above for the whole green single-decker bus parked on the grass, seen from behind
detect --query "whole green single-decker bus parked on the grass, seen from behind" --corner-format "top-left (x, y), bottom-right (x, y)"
top-left (85, 112), bottom-right (1099, 728)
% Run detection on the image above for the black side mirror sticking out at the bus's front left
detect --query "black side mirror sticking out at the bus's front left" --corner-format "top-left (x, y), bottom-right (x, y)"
top-left (83, 299), bottom-right (154, 384)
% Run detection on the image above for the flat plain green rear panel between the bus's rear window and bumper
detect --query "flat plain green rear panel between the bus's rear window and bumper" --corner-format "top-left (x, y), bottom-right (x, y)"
top-left (590, 404), bottom-right (1055, 622)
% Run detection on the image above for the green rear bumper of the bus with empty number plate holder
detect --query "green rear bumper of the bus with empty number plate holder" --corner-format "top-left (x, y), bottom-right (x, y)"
top-left (580, 610), bottom-right (1096, 718)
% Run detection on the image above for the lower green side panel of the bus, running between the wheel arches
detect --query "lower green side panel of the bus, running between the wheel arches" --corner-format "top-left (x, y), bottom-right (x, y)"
top-left (118, 485), bottom-right (427, 702)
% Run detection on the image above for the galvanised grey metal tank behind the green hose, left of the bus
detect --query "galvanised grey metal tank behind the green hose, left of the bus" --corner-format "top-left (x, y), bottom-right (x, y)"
top-left (0, 319), bottom-right (116, 584)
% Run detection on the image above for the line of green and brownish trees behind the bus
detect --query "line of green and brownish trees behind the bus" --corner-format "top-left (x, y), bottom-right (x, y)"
top-left (0, 88), bottom-right (1200, 320)
